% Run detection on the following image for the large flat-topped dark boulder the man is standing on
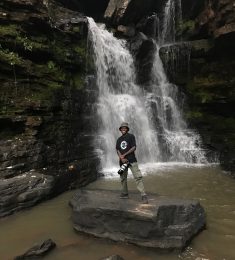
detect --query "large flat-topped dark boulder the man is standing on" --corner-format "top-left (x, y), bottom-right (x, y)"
top-left (70, 190), bottom-right (205, 250)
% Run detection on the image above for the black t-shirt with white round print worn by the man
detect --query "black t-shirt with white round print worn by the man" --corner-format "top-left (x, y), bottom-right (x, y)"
top-left (116, 133), bottom-right (137, 163)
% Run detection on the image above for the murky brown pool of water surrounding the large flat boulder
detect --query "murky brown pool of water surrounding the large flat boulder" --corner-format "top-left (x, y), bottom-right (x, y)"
top-left (0, 166), bottom-right (235, 260)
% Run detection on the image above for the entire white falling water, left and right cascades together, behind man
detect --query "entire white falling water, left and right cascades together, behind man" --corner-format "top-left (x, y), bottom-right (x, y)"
top-left (88, 0), bottom-right (207, 169)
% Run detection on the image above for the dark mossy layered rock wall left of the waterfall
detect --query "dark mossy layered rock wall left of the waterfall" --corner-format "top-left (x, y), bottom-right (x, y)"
top-left (0, 0), bottom-right (99, 215)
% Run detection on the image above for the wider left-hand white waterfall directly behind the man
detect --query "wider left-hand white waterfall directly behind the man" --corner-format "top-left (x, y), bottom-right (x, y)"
top-left (88, 18), bottom-right (162, 168)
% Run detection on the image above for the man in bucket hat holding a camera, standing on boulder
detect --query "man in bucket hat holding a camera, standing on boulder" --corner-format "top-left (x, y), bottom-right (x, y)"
top-left (116, 123), bottom-right (148, 204)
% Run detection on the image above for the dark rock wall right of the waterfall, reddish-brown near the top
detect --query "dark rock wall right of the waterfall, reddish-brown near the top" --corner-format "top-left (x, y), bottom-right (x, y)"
top-left (175, 0), bottom-right (235, 174)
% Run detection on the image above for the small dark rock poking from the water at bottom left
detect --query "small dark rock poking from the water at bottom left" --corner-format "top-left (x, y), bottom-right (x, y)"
top-left (14, 239), bottom-right (56, 260)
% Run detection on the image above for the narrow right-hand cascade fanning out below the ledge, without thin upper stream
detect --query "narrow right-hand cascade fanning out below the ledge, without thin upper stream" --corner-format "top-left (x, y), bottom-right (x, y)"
top-left (146, 44), bottom-right (207, 163)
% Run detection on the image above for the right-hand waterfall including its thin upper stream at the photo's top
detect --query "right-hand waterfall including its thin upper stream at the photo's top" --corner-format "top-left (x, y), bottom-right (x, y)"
top-left (150, 0), bottom-right (207, 163)
